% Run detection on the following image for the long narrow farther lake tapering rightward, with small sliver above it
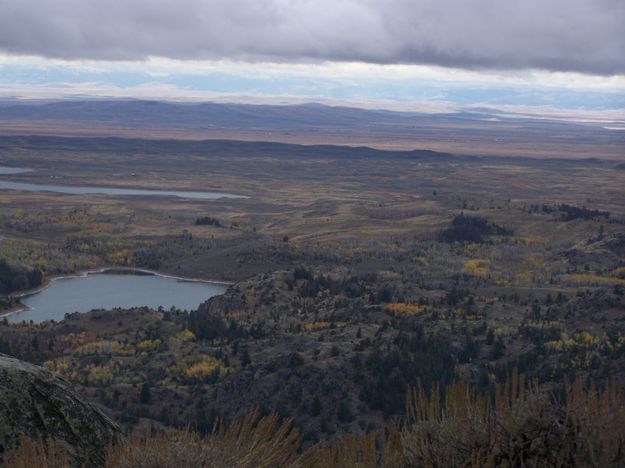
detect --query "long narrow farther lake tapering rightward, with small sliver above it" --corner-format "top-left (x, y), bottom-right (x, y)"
top-left (0, 166), bottom-right (247, 200)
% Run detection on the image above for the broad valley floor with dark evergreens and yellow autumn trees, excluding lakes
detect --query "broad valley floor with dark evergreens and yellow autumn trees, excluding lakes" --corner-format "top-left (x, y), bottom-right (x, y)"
top-left (0, 102), bottom-right (625, 464)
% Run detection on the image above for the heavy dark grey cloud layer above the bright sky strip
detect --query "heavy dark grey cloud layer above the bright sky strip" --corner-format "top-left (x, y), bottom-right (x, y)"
top-left (0, 0), bottom-right (625, 74)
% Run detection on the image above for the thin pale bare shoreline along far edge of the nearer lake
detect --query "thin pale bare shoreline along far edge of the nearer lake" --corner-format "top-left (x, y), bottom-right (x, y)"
top-left (0, 266), bottom-right (234, 320)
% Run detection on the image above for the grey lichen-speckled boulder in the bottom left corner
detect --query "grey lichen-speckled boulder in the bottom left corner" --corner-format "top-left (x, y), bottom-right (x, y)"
top-left (0, 354), bottom-right (119, 466)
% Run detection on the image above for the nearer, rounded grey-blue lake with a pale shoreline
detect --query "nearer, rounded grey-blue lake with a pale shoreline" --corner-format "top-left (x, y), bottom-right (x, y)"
top-left (7, 273), bottom-right (227, 323)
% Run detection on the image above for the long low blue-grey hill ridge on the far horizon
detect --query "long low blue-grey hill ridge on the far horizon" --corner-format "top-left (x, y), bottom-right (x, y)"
top-left (0, 100), bottom-right (504, 128)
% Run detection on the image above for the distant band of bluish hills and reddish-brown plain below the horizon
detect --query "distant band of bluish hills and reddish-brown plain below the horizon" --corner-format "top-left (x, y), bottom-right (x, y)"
top-left (0, 100), bottom-right (625, 159)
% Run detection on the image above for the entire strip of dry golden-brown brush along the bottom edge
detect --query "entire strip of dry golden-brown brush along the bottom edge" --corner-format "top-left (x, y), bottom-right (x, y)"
top-left (7, 373), bottom-right (625, 468)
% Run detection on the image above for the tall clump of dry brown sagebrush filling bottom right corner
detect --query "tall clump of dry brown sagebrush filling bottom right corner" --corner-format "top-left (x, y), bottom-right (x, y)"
top-left (401, 373), bottom-right (625, 467)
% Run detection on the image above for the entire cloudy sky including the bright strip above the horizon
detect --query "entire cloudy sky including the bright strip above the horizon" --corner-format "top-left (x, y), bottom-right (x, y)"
top-left (0, 0), bottom-right (625, 107)
